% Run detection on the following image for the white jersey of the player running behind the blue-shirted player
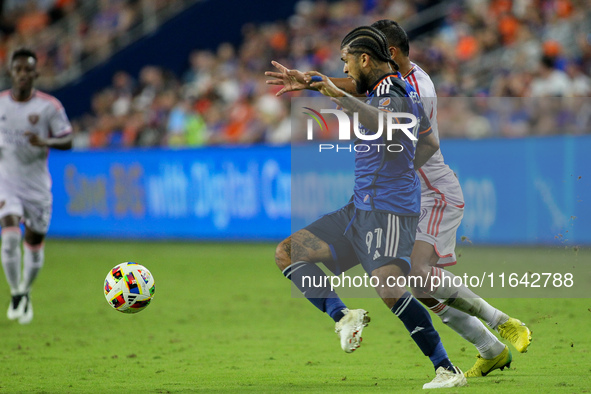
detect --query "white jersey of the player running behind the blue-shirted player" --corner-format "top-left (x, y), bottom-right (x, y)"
top-left (404, 63), bottom-right (463, 205)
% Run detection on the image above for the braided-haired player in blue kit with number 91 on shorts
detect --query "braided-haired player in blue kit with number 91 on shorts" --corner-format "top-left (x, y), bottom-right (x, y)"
top-left (276, 26), bottom-right (466, 388)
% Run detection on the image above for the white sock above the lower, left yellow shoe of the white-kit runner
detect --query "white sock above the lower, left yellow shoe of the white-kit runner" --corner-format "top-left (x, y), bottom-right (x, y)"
top-left (429, 303), bottom-right (505, 360)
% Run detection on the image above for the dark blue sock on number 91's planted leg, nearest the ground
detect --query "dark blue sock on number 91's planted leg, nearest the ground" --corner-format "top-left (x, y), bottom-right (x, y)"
top-left (392, 291), bottom-right (453, 371)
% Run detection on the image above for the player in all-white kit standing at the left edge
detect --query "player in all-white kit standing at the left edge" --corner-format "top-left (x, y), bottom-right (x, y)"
top-left (0, 49), bottom-right (72, 324)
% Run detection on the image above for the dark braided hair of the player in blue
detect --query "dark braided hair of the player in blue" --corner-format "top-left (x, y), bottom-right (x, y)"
top-left (341, 26), bottom-right (399, 70)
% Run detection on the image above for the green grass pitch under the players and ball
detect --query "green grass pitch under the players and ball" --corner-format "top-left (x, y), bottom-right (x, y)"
top-left (0, 239), bottom-right (591, 393)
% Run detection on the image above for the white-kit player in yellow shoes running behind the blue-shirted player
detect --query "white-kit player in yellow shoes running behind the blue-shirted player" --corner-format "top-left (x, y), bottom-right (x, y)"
top-left (266, 20), bottom-right (531, 377)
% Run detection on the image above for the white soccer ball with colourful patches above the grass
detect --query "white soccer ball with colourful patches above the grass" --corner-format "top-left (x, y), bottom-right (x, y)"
top-left (104, 262), bottom-right (155, 313)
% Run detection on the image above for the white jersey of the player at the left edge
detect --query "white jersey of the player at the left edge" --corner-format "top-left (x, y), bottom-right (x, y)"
top-left (0, 90), bottom-right (72, 202)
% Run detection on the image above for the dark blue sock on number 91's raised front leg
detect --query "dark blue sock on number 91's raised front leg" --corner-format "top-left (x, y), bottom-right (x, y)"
top-left (283, 261), bottom-right (346, 322)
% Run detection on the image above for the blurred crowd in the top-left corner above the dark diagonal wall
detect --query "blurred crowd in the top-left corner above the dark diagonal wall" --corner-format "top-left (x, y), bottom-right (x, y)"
top-left (0, 0), bottom-right (194, 89)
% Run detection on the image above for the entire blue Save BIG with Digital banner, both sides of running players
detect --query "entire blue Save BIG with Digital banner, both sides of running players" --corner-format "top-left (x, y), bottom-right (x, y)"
top-left (49, 136), bottom-right (591, 245)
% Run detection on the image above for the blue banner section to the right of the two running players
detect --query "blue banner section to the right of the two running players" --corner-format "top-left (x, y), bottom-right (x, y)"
top-left (442, 136), bottom-right (591, 245)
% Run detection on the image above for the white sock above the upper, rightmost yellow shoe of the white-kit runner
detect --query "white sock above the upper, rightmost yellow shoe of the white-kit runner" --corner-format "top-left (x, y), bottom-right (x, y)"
top-left (427, 267), bottom-right (509, 330)
